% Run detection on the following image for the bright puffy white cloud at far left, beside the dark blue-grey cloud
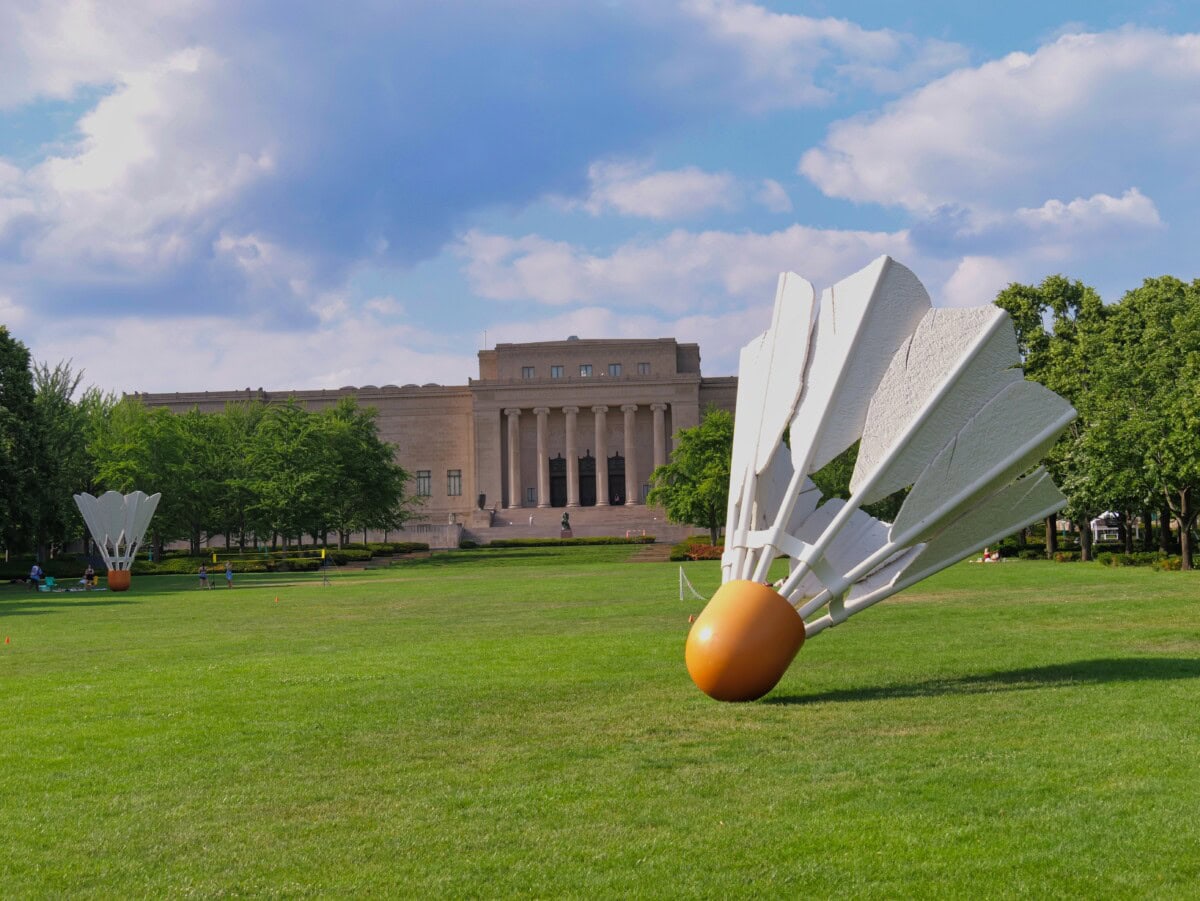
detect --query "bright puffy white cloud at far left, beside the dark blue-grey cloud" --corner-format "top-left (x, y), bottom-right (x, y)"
top-left (0, 48), bottom-right (274, 292)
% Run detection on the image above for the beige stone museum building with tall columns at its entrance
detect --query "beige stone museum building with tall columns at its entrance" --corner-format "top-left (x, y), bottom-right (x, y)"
top-left (138, 336), bottom-right (737, 528)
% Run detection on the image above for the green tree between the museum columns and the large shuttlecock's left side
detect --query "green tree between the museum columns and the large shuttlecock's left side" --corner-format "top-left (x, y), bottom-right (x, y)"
top-left (646, 407), bottom-right (733, 545)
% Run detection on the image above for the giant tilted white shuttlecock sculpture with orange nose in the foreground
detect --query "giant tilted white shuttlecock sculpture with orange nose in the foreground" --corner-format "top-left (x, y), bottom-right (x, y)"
top-left (686, 257), bottom-right (1075, 701)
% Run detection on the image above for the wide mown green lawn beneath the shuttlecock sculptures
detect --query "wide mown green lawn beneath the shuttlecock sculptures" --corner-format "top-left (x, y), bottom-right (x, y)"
top-left (0, 547), bottom-right (1200, 897)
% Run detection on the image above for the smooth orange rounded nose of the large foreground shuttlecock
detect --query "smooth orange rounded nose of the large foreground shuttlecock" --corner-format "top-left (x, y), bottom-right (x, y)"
top-left (684, 581), bottom-right (804, 701)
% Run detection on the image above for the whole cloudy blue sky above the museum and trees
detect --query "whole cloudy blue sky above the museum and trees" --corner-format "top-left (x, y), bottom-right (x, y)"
top-left (0, 0), bottom-right (1200, 391)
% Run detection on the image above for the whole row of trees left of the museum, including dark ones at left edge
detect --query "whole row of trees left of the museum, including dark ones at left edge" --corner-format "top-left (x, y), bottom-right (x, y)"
top-left (0, 326), bottom-right (416, 557)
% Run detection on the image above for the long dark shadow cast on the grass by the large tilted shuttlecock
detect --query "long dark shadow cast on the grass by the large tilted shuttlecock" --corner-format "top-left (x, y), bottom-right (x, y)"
top-left (762, 657), bottom-right (1200, 704)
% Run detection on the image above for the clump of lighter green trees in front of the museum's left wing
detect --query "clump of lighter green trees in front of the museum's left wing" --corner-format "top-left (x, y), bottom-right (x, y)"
top-left (89, 397), bottom-right (413, 553)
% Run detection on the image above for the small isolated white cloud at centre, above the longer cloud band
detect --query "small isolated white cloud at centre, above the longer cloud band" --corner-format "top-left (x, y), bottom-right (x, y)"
top-left (583, 162), bottom-right (742, 220)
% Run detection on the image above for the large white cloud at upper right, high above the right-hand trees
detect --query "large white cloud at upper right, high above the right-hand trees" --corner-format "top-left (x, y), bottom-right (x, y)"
top-left (799, 29), bottom-right (1200, 214)
